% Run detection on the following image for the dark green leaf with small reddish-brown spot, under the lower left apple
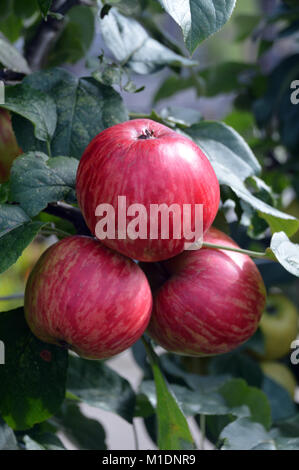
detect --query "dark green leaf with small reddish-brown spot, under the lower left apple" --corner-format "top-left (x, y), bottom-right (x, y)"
top-left (0, 308), bottom-right (67, 430)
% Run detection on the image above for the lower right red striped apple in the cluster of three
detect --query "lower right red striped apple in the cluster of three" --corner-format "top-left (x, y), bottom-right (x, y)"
top-left (147, 228), bottom-right (266, 356)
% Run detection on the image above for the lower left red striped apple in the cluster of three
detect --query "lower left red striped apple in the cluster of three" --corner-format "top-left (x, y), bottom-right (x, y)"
top-left (25, 236), bottom-right (152, 359)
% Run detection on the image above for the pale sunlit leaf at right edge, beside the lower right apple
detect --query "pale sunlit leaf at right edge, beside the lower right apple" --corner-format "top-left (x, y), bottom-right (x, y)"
top-left (270, 232), bottom-right (299, 277)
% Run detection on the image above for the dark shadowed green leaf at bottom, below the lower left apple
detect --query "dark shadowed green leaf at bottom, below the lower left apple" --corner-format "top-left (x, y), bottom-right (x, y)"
top-left (52, 401), bottom-right (107, 450)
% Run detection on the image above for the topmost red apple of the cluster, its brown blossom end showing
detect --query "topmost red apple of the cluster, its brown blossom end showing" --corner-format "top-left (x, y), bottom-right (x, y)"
top-left (77, 119), bottom-right (220, 261)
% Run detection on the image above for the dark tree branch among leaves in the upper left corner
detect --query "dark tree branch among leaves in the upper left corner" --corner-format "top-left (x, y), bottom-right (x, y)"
top-left (25, 0), bottom-right (81, 71)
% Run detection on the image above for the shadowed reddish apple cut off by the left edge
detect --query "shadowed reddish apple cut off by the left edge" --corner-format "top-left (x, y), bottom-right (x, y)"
top-left (0, 108), bottom-right (22, 183)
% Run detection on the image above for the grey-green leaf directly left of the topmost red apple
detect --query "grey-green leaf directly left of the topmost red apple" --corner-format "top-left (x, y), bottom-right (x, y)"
top-left (10, 152), bottom-right (78, 217)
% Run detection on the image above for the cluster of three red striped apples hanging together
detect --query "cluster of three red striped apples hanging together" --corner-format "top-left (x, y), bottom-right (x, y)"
top-left (25, 119), bottom-right (266, 359)
